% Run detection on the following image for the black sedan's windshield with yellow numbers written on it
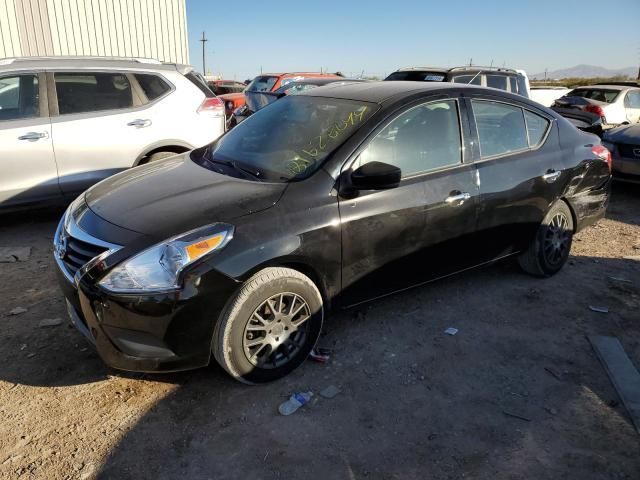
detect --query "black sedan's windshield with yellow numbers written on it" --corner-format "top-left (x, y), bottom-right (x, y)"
top-left (192, 95), bottom-right (378, 182)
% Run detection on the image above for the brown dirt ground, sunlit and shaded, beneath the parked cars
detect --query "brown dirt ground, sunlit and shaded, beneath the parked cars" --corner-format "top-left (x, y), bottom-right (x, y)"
top-left (0, 184), bottom-right (640, 480)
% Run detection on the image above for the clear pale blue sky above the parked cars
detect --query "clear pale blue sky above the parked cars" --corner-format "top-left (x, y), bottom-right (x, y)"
top-left (187, 0), bottom-right (640, 80)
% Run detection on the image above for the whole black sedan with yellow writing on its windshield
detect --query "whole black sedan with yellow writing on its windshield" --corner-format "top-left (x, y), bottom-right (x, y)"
top-left (54, 82), bottom-right (611, 383)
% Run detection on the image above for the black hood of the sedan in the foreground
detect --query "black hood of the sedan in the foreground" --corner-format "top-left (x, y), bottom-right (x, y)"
top-left (85, 153), bottom-right (287, 239)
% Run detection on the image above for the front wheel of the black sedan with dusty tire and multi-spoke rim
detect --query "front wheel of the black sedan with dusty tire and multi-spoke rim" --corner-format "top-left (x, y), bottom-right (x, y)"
top-left (211, 267), bottom-right (324, 384)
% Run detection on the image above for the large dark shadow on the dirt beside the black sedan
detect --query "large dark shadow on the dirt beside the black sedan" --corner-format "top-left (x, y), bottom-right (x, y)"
top-left (86, 253), bottom-right (640, 479)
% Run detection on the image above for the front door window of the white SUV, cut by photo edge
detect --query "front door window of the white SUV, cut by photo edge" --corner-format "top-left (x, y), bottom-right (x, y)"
top-left (0, 75), bottom-right (40, 121)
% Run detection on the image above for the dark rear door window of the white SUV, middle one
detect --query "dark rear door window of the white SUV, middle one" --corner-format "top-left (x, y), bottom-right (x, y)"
top-left (54, 72), bottom-right (133, 115)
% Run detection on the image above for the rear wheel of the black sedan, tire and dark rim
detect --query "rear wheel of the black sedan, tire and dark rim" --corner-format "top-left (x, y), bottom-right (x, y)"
top-left (518, 201), bottom-right (574, 277)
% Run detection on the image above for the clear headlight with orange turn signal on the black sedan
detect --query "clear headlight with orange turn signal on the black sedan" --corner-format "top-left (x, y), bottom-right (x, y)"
top-left (99, 223), bottom-right (233, 293)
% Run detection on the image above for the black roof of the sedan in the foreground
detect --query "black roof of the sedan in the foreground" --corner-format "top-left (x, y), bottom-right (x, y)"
top-left (298, 81), bottom-right (482, 103)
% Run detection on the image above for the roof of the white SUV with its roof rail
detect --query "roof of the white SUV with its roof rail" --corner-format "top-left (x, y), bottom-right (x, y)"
top-left (0, 56), bottom-right (192, 73)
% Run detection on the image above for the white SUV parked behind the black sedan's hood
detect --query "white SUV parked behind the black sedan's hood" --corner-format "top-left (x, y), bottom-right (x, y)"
top-left (0, 57), bottom-right (225, 209)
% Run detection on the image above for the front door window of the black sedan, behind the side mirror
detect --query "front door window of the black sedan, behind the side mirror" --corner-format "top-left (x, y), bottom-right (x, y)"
top-left (354, 100), bottom-right (462, 178)
